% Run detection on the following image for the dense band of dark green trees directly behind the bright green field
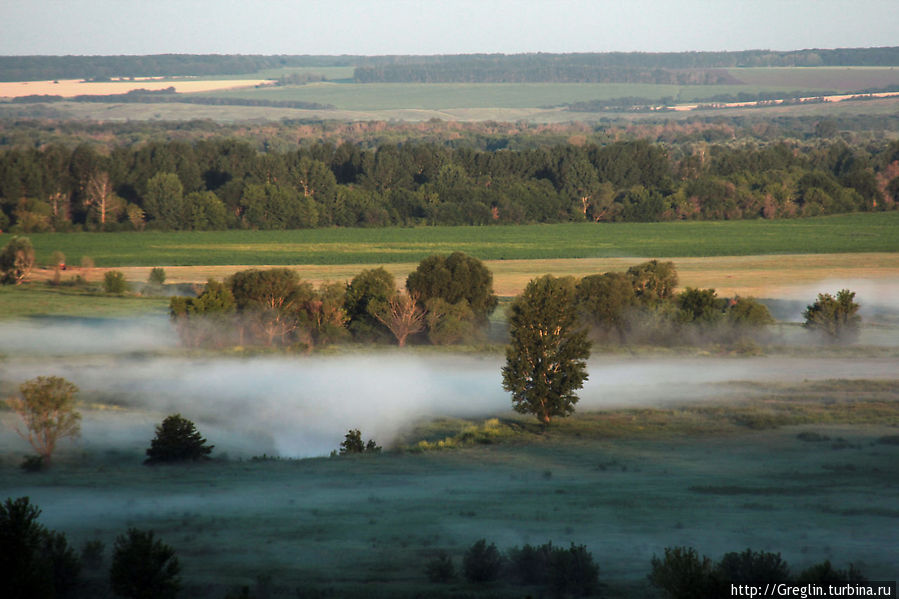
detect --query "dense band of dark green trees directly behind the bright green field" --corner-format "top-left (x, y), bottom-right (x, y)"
top-left (0, 139), bottom-right (899, 232)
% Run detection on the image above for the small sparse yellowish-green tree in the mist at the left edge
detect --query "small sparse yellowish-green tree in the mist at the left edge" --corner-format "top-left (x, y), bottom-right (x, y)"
top-left (7, 376), bottom-right (81, 463)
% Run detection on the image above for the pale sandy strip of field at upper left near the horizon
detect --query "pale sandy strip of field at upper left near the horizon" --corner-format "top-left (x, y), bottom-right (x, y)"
top-left (0, 79), bottom-right (274, 98)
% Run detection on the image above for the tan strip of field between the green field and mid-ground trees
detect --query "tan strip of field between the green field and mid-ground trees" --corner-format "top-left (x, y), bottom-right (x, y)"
top-left (45, 253), bottom-right (899, 299)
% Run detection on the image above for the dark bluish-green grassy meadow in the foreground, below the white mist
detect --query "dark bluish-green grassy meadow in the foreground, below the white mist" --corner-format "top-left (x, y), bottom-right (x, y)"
top-left (0, 380), bottom-right (899, 598)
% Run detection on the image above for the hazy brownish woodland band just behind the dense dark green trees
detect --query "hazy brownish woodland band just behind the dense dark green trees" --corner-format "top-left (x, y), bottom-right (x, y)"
top-left (0, 113), bottom-right (899, 158)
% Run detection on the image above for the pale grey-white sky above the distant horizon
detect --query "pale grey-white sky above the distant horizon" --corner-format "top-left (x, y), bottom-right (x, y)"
top-left (0, 0), bottom-right (899, 55)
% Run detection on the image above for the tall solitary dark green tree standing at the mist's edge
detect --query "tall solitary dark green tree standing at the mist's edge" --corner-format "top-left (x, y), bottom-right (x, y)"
top-left (503, 275), bottom-right (590, 426)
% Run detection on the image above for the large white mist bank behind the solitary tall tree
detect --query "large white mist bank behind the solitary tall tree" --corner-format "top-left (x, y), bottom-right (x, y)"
top-left (0, 352), bottom-right (896, 458)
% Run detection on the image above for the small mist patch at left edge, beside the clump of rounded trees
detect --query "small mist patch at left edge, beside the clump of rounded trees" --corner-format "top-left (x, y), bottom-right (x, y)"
top-left (0, 316), bottom-right (178, 356)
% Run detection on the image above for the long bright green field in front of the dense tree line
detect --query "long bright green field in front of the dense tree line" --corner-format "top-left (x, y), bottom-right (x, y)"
top-left (21, 212), bottom-right (899, 267)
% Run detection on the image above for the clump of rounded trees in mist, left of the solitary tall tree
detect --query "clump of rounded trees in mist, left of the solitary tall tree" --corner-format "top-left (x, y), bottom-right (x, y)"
top-left (170, 252), bottom-right (497, 350)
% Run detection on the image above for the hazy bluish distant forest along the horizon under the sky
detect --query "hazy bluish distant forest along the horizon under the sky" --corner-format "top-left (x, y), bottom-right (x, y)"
top-left (0, 47), bottom-right (899, 84)
